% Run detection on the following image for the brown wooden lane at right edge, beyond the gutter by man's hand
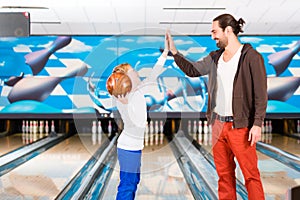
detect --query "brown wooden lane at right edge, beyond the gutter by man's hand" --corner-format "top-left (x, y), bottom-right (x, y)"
top-left (262, 133), bottom-right (300, 156)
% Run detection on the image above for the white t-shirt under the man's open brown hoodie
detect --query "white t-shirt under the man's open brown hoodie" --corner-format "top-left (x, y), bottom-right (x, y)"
top-left (214, 46), bottom-right (243, 116)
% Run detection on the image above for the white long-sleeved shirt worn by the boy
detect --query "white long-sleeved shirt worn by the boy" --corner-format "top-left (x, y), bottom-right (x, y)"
top-left (101, 55), bottom-right (166, 150)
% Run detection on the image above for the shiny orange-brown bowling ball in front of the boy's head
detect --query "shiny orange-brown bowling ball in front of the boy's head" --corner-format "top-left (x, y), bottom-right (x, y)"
top-left (106, 72), bottom-right (132, 97)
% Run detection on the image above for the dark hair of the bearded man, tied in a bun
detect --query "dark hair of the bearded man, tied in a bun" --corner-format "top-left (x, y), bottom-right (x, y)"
top-left (213, 14), bottom-right (245, 35)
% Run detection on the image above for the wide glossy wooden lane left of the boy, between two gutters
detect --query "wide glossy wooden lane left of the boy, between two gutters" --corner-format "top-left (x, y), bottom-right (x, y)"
top-left (0, 134), bottom-right (107, 199)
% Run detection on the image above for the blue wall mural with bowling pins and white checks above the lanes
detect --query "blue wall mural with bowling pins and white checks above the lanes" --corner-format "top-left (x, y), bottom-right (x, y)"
top-left (0, 36), bottom-right (300, 114)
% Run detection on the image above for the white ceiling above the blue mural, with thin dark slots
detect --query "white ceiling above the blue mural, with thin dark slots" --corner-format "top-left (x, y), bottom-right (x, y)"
top-left (0, 0), bottom-right (300, 35)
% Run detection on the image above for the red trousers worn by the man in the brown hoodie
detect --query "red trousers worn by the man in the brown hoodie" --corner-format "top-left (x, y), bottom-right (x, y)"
top-left (212, 120), bottom-right (264, 200)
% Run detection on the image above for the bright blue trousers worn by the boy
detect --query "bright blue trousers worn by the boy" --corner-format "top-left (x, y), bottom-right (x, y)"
top-left (116, 148), bottom-right (142, 200)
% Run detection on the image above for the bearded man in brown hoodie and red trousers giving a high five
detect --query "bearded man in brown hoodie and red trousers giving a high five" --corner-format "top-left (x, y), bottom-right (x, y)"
top-left (167, 14), bottom-right (267, 200)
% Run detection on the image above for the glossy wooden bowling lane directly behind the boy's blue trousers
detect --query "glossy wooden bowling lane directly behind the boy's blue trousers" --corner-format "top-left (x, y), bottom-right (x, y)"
top-left (103, 140), bottom-right (194, 200)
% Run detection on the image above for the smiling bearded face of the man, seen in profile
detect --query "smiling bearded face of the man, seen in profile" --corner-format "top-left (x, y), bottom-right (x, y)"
top-left (211, 21), bottom-right (228, 48)
